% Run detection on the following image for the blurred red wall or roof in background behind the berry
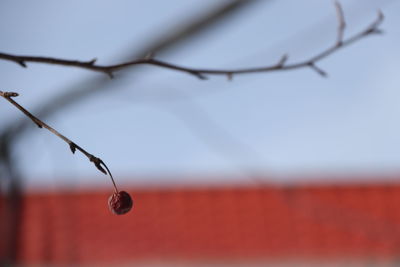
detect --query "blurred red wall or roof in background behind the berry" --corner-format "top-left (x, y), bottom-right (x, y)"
top-left (2, 184), bottom-right (400, 264)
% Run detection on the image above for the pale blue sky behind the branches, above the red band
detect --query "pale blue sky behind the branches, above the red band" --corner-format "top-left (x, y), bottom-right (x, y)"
top-left (0, 0), bottom-right (400, 189)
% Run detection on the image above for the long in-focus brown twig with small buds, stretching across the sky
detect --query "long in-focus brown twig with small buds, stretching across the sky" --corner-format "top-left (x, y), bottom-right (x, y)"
top-left (0, 2), bottom-right (384, 80)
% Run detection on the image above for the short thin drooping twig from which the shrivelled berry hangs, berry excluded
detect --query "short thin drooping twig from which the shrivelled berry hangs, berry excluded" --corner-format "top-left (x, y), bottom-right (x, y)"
top-left (0, 91), bottom-right (118, 192)
